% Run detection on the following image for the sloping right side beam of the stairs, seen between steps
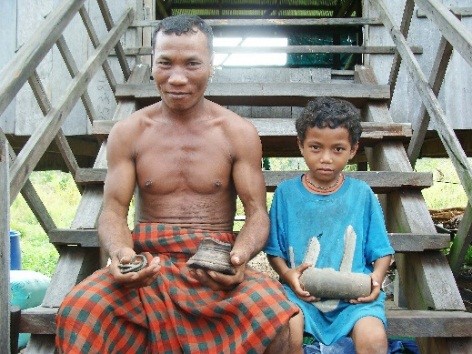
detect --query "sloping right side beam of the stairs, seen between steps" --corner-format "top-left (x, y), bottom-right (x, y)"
top-left (356, 65), bottom-right (465, 311)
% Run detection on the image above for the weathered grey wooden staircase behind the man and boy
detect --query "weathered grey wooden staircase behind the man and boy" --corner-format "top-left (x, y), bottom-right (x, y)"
top-left (0, 1), bottom-right (472, 353)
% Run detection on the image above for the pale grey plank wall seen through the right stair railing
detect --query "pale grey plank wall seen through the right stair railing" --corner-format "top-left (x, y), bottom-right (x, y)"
top-left (364, 0), bottom-right (472, 129)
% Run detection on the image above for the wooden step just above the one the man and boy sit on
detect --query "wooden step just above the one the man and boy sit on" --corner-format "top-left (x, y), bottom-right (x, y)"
top-left (48, 229), bottom-right (450, 253)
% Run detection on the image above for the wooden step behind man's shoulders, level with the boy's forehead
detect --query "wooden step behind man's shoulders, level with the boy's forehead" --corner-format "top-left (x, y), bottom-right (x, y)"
top-left (92, 119), bottom-right (412, 157)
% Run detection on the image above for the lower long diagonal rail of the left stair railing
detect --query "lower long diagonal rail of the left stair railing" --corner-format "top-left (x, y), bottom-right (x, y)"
top-left (10, 10), bottom-right (133, 199)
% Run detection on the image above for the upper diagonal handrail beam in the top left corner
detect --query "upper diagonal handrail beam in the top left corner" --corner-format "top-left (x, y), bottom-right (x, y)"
top-left (0, 0), bottom-right (85, 115)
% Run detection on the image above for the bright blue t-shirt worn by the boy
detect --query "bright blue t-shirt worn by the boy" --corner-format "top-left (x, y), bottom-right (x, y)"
top-left (265, 176), bottom-right (394, 345)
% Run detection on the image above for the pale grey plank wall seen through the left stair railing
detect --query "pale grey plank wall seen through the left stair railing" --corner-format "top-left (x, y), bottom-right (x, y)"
top-left (0, 0), bottom-right (139, 135)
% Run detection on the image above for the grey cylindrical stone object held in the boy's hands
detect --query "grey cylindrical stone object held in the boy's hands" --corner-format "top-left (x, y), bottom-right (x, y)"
top-left (300, 267), bottom-right (371, 300)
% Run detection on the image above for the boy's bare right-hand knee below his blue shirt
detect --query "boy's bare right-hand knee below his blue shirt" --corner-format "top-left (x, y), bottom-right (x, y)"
top-left (351, 317), bottom-right (388, 354)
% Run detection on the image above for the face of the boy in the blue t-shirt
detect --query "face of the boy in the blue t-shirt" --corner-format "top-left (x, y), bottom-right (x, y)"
top-left (298, 127), bottom-right (359, 187)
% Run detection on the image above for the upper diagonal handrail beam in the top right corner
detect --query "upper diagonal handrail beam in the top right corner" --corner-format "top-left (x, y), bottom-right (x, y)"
top-left (415, 0), bottom-right (472, 66)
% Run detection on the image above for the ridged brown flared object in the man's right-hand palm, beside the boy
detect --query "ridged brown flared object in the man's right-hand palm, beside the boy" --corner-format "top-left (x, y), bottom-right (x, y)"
top-left (187, 237), bottom-right (236, 275)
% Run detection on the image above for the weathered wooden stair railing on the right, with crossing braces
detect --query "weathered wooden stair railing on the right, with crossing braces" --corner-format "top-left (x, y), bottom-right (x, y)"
top-left (369, 0), bottom-right (472, 272)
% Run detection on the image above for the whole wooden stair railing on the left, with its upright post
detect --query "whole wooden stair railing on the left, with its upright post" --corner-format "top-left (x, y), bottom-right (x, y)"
top-left (0, 0), bottom-right (134, 347)
